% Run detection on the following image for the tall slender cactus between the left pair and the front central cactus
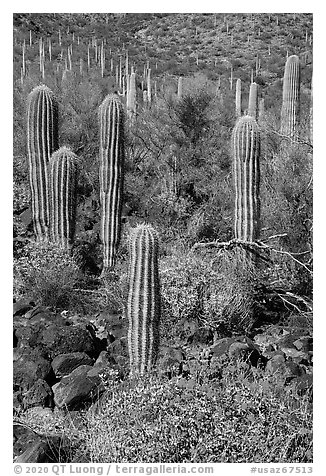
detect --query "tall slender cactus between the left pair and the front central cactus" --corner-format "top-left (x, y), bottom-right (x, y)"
top-left (99, 94), bottom-right (125, 271)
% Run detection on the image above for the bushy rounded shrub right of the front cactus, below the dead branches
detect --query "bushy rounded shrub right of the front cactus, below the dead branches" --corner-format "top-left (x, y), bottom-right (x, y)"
top-left (160, 244), bottom-right (261, 339)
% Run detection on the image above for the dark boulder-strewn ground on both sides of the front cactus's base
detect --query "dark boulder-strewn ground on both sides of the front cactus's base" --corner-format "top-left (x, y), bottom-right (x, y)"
top-left (13, 301), bottom-right (313, 463)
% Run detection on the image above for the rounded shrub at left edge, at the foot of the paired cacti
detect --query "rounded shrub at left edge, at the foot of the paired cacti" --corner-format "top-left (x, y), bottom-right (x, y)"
top-left (13, 242), bottom-right (81, 309)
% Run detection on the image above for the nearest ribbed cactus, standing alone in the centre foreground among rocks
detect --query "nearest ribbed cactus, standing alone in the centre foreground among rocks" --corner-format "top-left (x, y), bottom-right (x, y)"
top-left (127, 224), bottom-right (161, 375)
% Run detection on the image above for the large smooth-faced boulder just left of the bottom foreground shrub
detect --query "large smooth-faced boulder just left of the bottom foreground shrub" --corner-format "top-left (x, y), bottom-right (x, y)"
top-left (52, 365), bottom-right (104, 410)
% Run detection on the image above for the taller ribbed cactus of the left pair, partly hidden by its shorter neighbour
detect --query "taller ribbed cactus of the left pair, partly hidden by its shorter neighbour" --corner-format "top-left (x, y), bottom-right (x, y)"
top-left (27, 85), bottom-right (58, 241)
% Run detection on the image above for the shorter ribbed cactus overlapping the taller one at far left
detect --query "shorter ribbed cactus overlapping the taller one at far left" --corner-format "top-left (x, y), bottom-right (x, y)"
top-left (48, 147), bottom-right (78, 248)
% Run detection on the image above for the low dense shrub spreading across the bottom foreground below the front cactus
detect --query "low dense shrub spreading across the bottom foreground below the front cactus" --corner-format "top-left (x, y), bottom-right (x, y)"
top-left (74, 364), bottom-right (312, 463)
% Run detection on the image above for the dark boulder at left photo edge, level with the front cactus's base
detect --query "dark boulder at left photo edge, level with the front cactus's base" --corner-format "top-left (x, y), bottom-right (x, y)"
top-left (13, 348), bottom-right (54, 392)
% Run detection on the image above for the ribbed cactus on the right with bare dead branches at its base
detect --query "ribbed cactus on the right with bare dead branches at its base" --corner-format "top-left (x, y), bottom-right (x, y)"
top-left (232, 116), bottom-right (260, 242)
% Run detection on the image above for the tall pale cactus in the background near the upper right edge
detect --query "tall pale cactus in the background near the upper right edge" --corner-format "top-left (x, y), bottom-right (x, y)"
top-left (281, 55), bottom-right (300, 138)
